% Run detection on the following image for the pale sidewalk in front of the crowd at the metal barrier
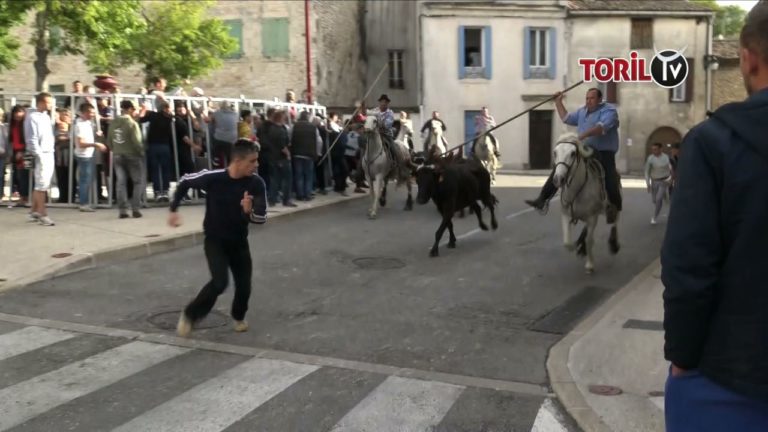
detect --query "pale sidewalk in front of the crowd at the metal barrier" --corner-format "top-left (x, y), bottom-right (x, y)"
top-left (0, 192), bottom-right (368, 291)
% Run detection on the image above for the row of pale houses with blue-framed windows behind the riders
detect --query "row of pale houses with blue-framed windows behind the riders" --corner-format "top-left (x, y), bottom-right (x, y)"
top-left (366, 0), bottom-right (714, 172)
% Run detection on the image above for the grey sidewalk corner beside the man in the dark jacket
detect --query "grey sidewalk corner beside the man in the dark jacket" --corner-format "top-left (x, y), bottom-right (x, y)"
top-left (547, 260), bottom-right (668, 432)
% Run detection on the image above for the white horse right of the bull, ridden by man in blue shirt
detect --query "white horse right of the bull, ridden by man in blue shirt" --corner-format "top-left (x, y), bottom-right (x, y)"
top-left (552, 133), bottom-right (619, 273)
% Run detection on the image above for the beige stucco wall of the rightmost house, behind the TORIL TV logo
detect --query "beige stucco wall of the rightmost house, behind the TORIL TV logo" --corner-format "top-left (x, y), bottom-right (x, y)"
top-left (566, 17), bottom-right (707, 173)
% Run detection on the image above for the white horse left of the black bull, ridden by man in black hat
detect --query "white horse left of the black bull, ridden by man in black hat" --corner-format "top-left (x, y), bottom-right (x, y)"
top-left (360, 113), bottom-right (413, 219)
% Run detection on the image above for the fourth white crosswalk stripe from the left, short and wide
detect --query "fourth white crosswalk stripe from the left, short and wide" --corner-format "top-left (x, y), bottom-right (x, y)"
top-left (332, 376), bottom-right (464, 432)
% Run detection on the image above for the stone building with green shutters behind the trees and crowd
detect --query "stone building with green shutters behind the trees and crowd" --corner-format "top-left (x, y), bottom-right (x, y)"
top-left (0, 0), bottom-right (365, 107)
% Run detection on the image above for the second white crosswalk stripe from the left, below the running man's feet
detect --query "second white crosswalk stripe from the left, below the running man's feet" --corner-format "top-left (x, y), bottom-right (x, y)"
top-left (0, 342), bottom-right (188, 431)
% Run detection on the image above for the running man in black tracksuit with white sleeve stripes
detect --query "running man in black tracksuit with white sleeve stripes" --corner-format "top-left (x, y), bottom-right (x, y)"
top-left (168, 139), bottom-right (267, 337)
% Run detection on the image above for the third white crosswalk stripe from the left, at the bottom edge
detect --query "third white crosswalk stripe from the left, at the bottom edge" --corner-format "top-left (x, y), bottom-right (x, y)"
top-left (113, 359), bottom-right (318, 432)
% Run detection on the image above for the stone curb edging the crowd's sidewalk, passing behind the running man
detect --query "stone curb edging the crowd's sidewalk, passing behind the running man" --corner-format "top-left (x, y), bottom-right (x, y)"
top-left (0, 194), bottom-right (368, 293)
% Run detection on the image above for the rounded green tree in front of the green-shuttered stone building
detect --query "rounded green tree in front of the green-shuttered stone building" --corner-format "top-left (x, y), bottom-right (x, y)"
top-left (134, 0), bottom-right (238, 86)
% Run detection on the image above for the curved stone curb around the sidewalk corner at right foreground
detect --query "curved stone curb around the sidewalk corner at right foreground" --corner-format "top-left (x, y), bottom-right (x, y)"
top-left (547, 259), bottom-right (661, 432)
